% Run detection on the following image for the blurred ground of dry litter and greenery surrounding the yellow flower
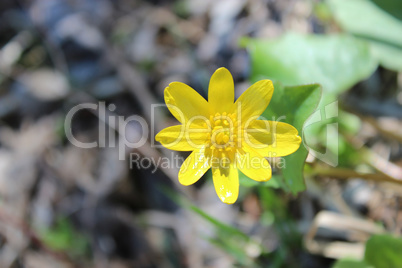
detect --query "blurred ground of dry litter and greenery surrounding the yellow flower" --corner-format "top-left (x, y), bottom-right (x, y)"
top-left (0, 0), bottom-right (402, 268)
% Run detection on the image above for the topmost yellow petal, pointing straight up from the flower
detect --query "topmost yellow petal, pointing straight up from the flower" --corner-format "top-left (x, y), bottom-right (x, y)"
top-left (208, 67), bottom-right (234, 114)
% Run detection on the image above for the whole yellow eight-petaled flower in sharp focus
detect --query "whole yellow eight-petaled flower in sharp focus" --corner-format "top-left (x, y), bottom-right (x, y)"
top-left (155, 68), bottom-right (301, 204)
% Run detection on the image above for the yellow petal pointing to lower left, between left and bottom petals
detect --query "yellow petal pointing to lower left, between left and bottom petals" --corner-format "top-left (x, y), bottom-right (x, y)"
top-left (179, 148), bottom-right (211, 186)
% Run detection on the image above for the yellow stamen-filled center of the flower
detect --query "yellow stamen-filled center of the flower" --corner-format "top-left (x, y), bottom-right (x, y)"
top-left (209, 113), bottom-right (238, 152)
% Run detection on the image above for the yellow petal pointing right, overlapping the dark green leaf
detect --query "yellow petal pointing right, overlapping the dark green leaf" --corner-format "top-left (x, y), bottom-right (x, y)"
top-left (243, 120), bottom-right (301, 157)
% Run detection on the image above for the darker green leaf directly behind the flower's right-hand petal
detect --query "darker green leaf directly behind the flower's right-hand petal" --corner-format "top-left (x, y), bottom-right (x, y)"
top-left (263, 83), bottom-right (321, 194)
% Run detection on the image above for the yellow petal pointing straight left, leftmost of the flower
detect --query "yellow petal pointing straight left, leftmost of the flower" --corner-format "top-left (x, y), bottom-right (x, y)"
top-left (155, 125), bottom-right (208, 151)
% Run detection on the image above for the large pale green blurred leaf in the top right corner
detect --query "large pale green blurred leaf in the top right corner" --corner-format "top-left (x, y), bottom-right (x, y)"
top-left (327, 0), bottom-right (402, 71)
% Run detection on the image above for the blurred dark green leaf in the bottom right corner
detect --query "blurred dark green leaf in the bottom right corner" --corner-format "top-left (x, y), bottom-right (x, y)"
top-left (364, 235), bottom-right (402, 268)
